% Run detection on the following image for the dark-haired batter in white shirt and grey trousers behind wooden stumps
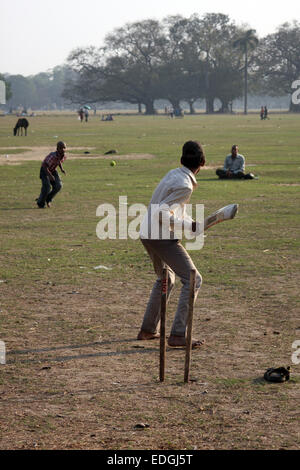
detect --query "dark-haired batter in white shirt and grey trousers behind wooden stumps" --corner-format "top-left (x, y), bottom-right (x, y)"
top-left (138, 141), bottom-right (205, 347)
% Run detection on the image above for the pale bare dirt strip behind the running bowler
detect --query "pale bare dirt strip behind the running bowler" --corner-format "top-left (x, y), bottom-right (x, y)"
top-left (0, 146), bottom-right (155, 165)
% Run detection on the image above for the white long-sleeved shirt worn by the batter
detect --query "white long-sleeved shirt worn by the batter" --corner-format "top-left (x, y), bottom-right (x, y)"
top-left (140, 166), bottom-right (201, 240)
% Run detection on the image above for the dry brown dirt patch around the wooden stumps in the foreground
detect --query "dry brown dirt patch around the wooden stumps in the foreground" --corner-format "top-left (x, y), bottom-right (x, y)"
top-left (0, 275), bottom-right (299, 450)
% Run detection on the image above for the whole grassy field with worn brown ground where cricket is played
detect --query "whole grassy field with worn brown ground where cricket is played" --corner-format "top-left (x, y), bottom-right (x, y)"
top-left (0, 114), bottom-right (300, 450)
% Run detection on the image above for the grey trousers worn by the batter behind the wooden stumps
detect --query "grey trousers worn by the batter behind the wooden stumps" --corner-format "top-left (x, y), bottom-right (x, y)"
top-left (141, 239), bottom-right (202, 336)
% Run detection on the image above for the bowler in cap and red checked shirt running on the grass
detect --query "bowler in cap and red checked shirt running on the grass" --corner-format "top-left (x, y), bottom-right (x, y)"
top-left (36, 142), bottom-right (66, 209)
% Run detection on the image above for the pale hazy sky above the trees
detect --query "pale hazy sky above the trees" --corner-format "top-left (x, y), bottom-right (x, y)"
top-left (0, 0), bottom-right (300, 76)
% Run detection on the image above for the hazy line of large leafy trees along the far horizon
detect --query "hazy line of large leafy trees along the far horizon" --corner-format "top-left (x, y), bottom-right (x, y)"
top-left (2, 13), bottom-right (300, 114)
